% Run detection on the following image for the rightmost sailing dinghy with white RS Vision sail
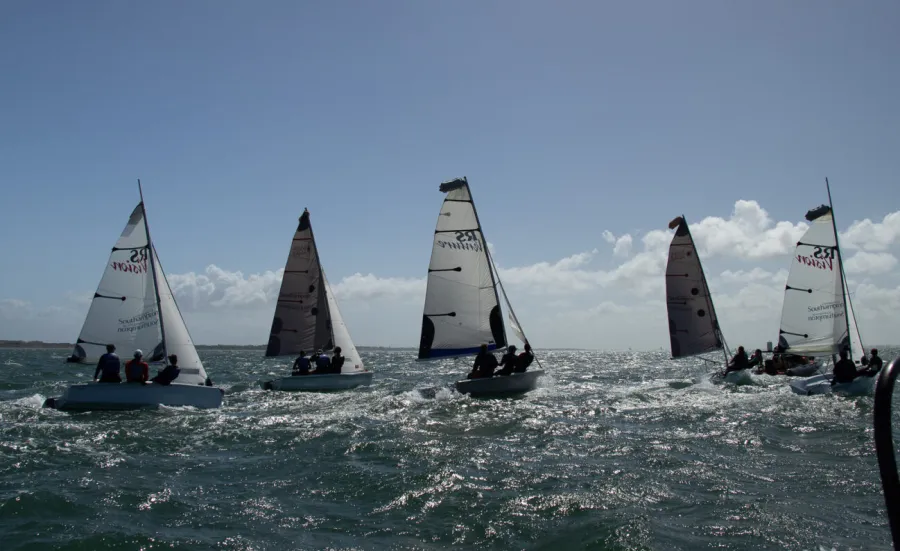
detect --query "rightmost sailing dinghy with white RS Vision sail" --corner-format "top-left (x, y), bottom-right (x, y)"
top-left (778, 180), bottom-right (875, 395)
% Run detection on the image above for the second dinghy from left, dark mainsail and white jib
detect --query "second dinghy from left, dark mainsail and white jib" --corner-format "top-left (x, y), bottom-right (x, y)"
top-left (260, 209), bottom-right (372, 391)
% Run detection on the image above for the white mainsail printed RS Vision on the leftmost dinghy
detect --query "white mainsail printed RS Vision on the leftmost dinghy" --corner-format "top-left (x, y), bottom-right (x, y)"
top-left (73, 204), bottom-right (163, 362)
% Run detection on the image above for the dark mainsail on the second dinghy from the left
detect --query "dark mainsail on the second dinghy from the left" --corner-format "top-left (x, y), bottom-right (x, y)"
top-left (266, 209), bottom-right (334, 356)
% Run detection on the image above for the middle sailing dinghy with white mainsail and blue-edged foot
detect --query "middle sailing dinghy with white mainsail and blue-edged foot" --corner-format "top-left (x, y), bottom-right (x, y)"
top-left (418, 177), bottom-right (544, 396)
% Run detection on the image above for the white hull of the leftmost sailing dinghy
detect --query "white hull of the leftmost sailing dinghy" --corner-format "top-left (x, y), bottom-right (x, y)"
top-left (44, 383), bottom-right (225, 411)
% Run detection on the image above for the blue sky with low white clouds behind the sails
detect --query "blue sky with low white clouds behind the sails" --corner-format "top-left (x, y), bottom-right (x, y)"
top-left (0, 0), bottom-right (900, 349)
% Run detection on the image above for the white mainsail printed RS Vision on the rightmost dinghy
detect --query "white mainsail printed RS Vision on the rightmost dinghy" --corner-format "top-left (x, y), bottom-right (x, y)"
top-left (778, 207), bottom-right (858, 359)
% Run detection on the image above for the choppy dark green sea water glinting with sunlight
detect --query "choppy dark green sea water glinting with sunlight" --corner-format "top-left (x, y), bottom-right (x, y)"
top-left (0, 350), bottom-right (900, 551)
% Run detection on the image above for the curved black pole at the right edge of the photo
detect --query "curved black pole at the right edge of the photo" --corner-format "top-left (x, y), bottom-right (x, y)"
top-left (873, 358), bottom-right (900, 550)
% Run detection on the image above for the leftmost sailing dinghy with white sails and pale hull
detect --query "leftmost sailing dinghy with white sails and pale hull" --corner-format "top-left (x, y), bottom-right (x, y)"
top-left (44, 182), bottom-right (224, 410)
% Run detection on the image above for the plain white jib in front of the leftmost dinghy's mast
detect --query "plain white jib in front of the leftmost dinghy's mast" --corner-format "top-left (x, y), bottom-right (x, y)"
top-left (153, 247), bottom-right (206, 385)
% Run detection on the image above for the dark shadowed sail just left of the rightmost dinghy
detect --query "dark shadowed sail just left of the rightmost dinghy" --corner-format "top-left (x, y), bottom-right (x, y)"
top-left (666, 216), bottom-right (725, 358)
